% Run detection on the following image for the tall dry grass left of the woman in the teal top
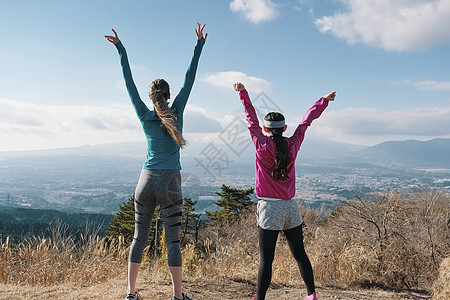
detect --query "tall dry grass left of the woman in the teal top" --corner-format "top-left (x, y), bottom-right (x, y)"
top-left (0, 225), bottom-right (128, 285)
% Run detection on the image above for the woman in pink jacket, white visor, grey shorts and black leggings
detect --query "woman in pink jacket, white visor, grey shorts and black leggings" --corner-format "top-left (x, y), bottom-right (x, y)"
top-left (233, 82), bottom-right (336, 300)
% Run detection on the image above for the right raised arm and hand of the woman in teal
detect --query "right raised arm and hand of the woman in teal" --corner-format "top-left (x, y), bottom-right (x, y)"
top-left (172, 23), bottom-right (208, 112)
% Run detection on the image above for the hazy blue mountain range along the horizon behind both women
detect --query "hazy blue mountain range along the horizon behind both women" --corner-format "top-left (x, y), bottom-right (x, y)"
top-left (0, 138), bottom-right (450, 173)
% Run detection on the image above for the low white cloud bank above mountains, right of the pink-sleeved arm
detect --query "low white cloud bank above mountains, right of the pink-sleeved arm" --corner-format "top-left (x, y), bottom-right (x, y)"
top-left (312, 105), bottom-right (450, 145)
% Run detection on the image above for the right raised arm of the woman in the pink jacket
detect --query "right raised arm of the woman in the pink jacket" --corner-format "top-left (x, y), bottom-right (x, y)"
top-left (291, 92), bottom-right (336, 151)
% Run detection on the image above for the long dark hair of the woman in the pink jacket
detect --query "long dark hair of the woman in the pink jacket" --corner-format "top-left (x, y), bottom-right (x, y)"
top-left (264, 112), bottom-right (290, 181)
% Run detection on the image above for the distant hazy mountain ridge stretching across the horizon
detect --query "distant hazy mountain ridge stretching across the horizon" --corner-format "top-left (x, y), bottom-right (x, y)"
top-left (0, 138), bottom-right (450, 168)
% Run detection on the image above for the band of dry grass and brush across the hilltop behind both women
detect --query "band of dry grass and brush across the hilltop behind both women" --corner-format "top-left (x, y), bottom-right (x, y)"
top-left (0, 191), bottom-right (450, 299)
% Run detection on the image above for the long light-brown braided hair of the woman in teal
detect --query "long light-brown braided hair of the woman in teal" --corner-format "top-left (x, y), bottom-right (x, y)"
top-left (150, 79), bottom-right (187, 148)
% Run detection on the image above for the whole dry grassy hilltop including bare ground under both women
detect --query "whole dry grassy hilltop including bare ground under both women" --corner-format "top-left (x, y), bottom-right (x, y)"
top-left (0, 190), bottom-right (450, 300)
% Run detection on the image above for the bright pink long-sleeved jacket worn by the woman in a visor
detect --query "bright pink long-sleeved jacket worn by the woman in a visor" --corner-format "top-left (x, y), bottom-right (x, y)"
top-left (239, 90), bottom-right (328, 200)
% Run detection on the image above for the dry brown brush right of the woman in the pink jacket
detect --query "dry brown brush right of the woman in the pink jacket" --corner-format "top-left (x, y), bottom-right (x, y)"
top-left (309, 190), bottom-right (450, 290)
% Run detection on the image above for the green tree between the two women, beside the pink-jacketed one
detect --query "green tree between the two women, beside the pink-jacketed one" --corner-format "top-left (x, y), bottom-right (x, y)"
top-left (206, 184), bottom-right (254, 225)
